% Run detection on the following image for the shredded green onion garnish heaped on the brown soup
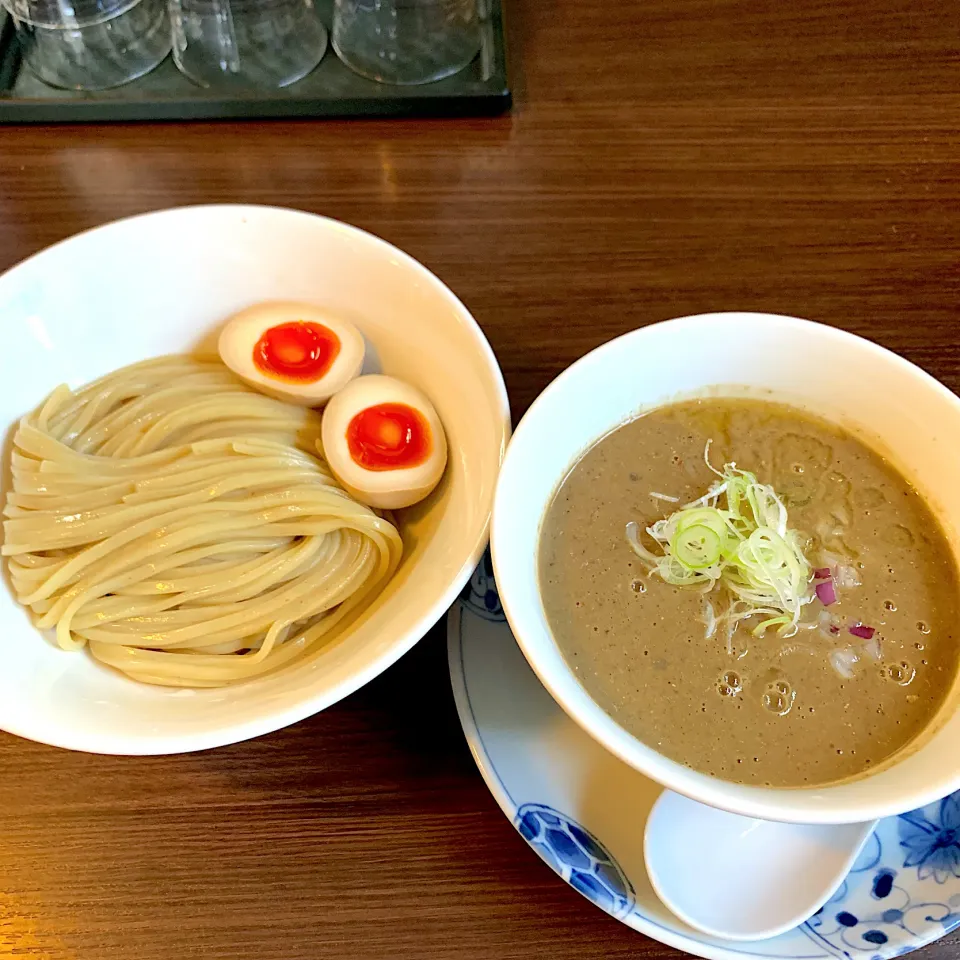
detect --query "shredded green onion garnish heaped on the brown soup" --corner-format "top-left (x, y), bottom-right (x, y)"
top-left (627, 441), bottom-right (815, 646)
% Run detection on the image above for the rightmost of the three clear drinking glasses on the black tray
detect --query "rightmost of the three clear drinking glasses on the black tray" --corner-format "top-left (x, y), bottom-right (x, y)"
top-left (333, 0), bottom-right (480, 84)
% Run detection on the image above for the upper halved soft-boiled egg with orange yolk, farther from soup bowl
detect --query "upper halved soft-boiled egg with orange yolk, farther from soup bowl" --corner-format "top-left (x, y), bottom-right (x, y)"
top-left (218, 301), bottom-right (364, 407)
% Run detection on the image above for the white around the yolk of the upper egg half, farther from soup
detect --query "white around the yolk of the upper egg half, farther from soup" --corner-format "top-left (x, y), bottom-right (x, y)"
top-left (217, 301), bottom-right (365, 407)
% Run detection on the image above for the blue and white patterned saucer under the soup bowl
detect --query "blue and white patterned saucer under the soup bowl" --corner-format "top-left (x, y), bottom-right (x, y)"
top-left (448, 557), bottom-right (960, 960)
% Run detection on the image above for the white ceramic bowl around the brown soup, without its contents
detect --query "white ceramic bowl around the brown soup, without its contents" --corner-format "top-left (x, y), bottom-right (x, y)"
top-left (491, 313), bottom-right (960, 823)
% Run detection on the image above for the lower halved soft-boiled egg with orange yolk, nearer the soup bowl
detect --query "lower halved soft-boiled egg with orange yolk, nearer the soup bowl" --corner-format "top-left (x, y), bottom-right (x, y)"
top-left (320, 375), bottom-right (447, 510)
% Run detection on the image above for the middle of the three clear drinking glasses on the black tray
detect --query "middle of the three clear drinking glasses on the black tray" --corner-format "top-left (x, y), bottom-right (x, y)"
top-left (170, 0), bottom-right (327, 90)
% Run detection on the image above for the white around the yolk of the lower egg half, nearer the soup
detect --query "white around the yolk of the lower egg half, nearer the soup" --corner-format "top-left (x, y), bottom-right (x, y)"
top-left (320, 374), bottom-right (447, 510)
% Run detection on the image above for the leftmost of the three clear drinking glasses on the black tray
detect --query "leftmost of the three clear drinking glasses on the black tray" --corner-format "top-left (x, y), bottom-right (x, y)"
top-left (2, 0), bottom-right (170, 90)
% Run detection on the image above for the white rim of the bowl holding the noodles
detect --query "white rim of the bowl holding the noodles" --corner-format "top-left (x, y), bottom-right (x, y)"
top-left (0, 203), bottom-right (511, 756)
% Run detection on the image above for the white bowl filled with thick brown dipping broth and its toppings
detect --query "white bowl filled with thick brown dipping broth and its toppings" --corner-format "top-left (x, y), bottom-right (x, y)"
top-left (491, 313), bottom-right (960, 823)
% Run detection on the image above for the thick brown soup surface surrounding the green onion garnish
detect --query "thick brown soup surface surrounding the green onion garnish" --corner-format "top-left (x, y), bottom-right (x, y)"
top-left (539, 399), bottom-right (960, 787)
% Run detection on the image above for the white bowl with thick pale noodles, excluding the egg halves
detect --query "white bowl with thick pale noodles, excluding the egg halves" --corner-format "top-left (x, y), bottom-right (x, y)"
top-left (0, 206), bottom-right (510, 754)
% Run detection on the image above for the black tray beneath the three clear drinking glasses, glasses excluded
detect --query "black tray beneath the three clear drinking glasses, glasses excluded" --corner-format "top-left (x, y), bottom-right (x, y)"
top-left (0, 0), bottom-right (510, 123)
